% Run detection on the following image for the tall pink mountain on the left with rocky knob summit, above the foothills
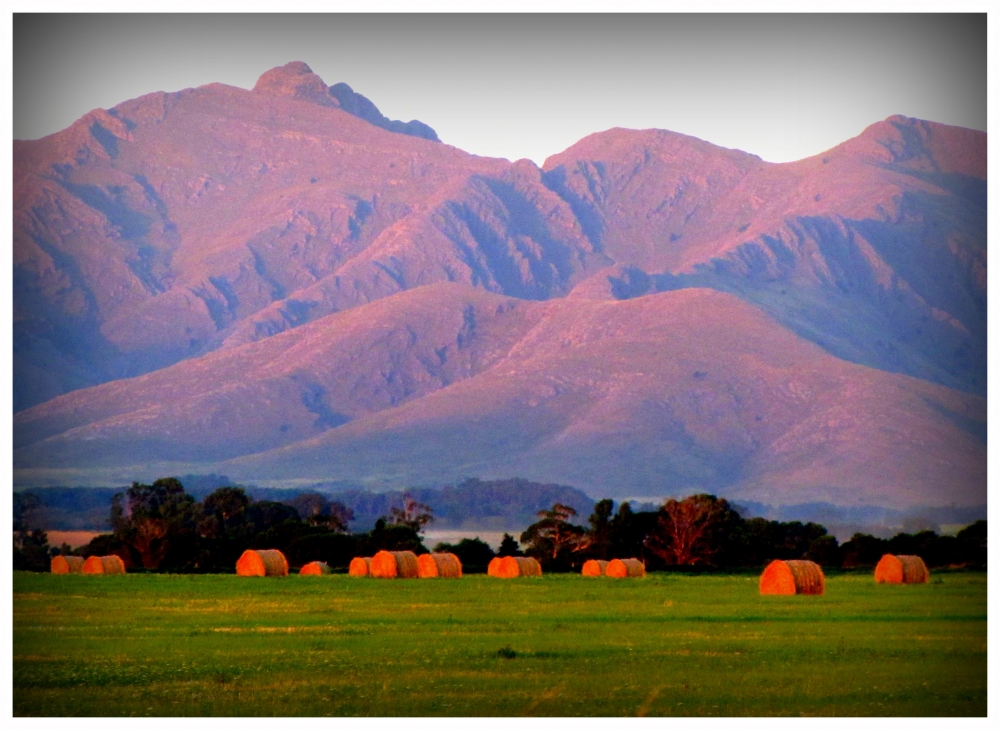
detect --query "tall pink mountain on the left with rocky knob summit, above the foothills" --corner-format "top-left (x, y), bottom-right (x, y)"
top-left (14, 64), bottom-right (609, 409)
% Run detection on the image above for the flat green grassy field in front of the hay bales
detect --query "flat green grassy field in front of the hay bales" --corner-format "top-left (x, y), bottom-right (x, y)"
top-left (13, 573), bottom-right (986, 716)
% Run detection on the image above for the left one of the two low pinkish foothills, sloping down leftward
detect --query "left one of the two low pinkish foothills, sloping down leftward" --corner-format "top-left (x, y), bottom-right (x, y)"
top-left (15, 284), bottom-right (541, 466)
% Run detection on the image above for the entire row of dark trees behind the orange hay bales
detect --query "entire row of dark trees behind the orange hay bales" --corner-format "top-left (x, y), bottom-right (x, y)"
top-left (14, 478), bottom-right (986, 573)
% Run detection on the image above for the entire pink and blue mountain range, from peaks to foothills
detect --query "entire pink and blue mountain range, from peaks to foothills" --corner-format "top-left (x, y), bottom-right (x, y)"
top-left (14, 63), bottom-right (986, 505)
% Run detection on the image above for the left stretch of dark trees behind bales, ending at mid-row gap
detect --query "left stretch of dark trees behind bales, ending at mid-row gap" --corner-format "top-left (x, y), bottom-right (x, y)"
top-left (14, 478), bottom-right (431, 573)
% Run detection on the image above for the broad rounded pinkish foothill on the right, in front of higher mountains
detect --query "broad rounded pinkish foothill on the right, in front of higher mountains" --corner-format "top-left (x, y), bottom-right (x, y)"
top-left (220, 289), bottom-right (986, 504)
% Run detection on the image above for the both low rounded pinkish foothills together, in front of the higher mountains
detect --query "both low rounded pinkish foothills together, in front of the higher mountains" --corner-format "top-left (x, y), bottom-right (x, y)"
top-left (15, 284), bottom-right (986, 505)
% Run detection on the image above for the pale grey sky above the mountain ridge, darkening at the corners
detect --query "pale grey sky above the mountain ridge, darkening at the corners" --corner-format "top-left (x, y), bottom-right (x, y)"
top-left (13, 14), bottom-right (986, 164)
